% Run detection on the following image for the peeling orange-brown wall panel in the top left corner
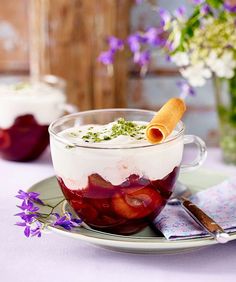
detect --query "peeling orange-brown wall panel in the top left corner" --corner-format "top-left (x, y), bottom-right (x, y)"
top-left (0, 0), bottom-right (29, 73)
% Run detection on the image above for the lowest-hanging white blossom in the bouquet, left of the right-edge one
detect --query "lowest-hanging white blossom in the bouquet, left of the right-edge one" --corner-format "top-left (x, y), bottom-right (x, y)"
top-left (180, 62), bottom-right (212, 87)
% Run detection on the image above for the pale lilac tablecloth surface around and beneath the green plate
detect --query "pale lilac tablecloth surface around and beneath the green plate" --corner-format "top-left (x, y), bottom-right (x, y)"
top-left (0, 148), bottom-right (236, 282)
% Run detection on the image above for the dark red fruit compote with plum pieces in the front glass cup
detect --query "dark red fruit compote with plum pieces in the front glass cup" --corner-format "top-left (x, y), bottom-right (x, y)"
top-left (58, 167), bottom-right (179, 235)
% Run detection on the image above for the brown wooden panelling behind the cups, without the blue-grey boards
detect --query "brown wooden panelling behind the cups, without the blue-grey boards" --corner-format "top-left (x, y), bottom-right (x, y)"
top-left (0, 0), bottom-right (133, 110)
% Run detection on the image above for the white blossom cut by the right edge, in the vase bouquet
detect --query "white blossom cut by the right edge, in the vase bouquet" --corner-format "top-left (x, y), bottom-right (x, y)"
top-left (206, 50), bottom-right (236, 79)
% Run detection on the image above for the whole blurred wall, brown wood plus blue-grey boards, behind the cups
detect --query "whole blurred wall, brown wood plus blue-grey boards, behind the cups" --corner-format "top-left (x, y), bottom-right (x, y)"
top-left (0, 0), bottom-right (221, 146)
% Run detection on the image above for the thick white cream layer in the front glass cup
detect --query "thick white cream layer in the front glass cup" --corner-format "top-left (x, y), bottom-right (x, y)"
top-left (50, 121), bottom-right (183, 190)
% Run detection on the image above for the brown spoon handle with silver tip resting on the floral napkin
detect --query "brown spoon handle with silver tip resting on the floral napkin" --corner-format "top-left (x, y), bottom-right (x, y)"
top-left (179, 197), bottom-right (230, 243)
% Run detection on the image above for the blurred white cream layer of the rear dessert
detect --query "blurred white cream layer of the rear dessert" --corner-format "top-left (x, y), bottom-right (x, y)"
top-left (0, 83), bottom-right (65, 128)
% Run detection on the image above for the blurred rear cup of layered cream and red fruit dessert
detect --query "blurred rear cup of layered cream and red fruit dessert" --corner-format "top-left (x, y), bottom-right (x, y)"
top-left (0, 75), bottom-right (73, 161)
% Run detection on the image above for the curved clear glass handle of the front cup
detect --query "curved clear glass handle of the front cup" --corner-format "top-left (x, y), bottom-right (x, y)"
top-left (180, 135), bottom-right (207, 172)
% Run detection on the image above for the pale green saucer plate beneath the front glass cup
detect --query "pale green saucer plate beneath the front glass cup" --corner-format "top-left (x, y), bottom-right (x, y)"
top-left (28, 169), bottom-right (236, 254)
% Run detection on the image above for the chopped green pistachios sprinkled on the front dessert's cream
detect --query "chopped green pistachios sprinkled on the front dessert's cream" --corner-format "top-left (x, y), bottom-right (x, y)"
top-left (82, 118), bottom-right (146, 143)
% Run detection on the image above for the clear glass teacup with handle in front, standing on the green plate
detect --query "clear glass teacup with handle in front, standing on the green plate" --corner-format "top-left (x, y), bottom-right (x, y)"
top-left (49, 109), bottom-right (206, 235)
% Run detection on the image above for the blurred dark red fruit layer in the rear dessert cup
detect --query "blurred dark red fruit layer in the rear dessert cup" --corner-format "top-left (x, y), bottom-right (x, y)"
top-left (0, 114), bottom-right (49, 162)
